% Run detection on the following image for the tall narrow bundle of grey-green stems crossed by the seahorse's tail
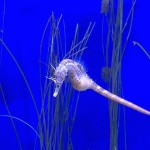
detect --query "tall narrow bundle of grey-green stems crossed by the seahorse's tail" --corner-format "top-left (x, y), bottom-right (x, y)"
top-left (101, 0), bottom-right (136, 150)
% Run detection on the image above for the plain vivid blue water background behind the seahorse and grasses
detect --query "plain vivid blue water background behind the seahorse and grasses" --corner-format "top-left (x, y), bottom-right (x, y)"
top-left (0, 0), bottom-right (150, 150)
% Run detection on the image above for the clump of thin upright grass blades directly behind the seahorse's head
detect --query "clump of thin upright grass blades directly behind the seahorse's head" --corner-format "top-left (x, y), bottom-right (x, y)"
top-left (40, 14), bottom-right (94, 149)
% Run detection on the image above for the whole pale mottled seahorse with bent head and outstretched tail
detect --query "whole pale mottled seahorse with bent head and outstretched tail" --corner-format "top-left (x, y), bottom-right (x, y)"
top-left (49, 59), bottom-right (150, 115)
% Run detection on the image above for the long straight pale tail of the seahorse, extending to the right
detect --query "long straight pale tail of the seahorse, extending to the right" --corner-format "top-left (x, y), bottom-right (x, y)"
top-left (92, 83), bottom-right (150, 115)
